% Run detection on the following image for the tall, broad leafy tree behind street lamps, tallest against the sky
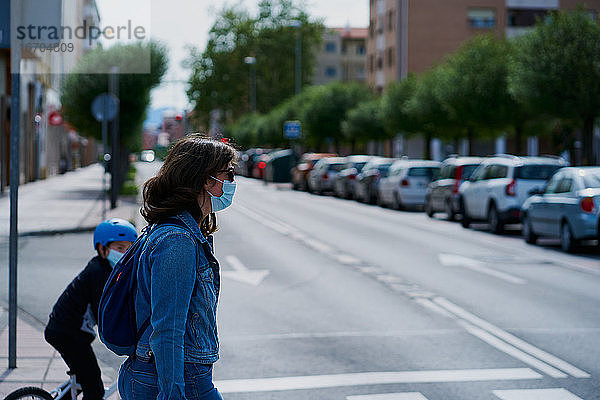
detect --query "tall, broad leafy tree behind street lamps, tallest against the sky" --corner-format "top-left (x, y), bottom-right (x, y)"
top-left (187, 0), bottom-right (323, 124)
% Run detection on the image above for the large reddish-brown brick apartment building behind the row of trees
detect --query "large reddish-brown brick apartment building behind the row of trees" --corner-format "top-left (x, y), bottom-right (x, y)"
top-left (367, 0), bottom-right (600, 158)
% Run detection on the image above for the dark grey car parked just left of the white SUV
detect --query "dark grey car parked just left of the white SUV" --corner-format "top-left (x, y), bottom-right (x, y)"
top-left (425, 157), bottom-right (483, 221)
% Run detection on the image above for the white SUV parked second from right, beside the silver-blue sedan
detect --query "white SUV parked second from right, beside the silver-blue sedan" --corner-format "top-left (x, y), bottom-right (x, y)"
top-left (458, 155), bottom-right (568, 233)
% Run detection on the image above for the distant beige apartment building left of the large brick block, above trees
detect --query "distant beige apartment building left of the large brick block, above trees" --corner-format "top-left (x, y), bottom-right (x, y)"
top-left (313, 27), bottom-right (368, 85)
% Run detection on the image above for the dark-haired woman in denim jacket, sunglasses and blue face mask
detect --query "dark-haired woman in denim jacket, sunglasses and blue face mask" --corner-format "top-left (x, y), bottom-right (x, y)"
top-left (119, 134), bottom-right (236, 400)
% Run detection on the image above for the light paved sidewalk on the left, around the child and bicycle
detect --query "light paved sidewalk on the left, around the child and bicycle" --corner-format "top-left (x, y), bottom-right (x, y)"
top-left (0, 164), bottom-right (144, 399)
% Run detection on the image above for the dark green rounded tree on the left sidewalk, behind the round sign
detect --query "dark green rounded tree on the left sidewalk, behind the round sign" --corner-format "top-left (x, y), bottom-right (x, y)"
top-left (61, 42), bottom-right (167, 149)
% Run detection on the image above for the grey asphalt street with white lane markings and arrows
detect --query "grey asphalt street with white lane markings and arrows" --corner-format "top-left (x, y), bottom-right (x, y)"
top-left (0, 162), bottom-right (600, 400)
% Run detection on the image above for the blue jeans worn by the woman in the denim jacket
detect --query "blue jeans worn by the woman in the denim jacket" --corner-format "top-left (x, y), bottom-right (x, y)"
top-left (119, 357), bottom-right (223, 400)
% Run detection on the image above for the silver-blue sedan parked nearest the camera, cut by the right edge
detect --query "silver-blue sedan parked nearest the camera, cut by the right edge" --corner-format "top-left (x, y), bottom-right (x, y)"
top-left (522, 167), bottom-right (600, 252)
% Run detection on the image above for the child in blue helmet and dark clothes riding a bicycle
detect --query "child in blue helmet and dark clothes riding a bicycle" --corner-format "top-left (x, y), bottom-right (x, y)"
top-left (44, 218), bottom-right (137, 400)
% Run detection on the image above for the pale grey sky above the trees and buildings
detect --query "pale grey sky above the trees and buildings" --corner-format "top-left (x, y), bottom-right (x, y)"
top-left (97, 0), bottom-right (369, 109)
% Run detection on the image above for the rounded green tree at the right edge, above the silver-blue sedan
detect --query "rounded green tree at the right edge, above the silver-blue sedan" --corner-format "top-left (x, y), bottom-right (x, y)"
top-left (509, 9), bottom-right (600, 164)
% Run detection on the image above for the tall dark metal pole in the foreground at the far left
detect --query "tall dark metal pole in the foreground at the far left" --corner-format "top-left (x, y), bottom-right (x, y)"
top-left (8, 46), bottom-right (21, 368)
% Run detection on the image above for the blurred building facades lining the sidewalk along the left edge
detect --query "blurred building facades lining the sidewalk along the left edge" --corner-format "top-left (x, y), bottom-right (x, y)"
top-left (0, 0), bottom-right (100, 190)
